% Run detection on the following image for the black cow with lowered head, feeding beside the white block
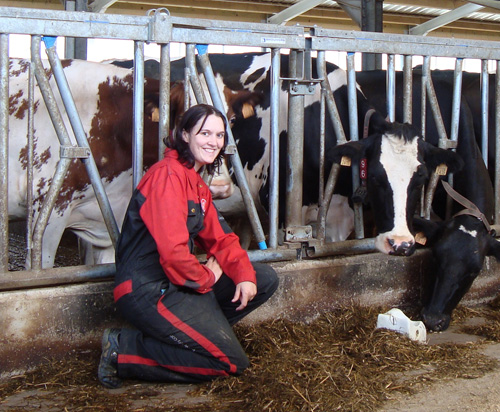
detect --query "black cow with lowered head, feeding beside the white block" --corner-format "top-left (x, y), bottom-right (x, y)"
top-left (358, 69), bottom-right (500, 331)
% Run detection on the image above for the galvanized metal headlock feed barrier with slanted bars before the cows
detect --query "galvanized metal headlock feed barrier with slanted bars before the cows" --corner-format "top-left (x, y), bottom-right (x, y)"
top-left (0, 7), bottom-right (500, 290)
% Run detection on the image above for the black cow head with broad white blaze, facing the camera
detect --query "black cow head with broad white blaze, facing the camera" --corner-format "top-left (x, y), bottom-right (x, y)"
top-left (328, 114), bottom-right (462, 256)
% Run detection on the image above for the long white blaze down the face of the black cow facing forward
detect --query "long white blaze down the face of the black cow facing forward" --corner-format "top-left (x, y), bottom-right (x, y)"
top-left (377, 135), bottom-right (421, 253)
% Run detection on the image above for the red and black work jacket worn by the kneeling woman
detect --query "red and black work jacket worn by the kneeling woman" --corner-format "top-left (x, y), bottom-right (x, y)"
top-left (115, 149), bottom-right (256, 300)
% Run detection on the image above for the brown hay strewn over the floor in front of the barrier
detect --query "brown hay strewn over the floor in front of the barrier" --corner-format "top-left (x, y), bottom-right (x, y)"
top-left (0, 306), bottom-right (500, 412)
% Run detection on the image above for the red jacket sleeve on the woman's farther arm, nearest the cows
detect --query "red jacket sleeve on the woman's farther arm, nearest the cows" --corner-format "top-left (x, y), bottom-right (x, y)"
top-left (196, 192), bottom-right (257, 285)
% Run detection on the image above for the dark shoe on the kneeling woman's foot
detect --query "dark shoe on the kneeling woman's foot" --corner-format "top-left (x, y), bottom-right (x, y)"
top-left (97, 329), bottom-right (123, 389)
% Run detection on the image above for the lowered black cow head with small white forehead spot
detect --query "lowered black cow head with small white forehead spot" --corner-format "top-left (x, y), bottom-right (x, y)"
top-left (414, 215), bottom-right (500, 331)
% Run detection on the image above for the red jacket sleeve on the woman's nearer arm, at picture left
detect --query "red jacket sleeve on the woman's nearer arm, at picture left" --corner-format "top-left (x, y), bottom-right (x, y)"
top-left (140, 169), bottom-right (215, 293)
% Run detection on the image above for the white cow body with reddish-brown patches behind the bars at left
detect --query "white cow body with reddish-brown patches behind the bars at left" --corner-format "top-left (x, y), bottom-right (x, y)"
top-left (8, 59), bottom-right (158, 267)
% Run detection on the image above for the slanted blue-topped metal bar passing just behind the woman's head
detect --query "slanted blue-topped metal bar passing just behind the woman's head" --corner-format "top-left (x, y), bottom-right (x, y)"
top-left (198, 48), bottom-right (267, 249)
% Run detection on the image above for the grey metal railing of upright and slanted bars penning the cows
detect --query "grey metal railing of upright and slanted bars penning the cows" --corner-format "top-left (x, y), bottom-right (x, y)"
top-left (0, 8), bottom-right (500, 289)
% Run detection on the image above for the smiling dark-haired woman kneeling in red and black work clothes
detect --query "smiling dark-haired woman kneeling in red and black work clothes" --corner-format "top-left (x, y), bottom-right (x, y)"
top-left (98, 105), bottom-right (278, 388)
